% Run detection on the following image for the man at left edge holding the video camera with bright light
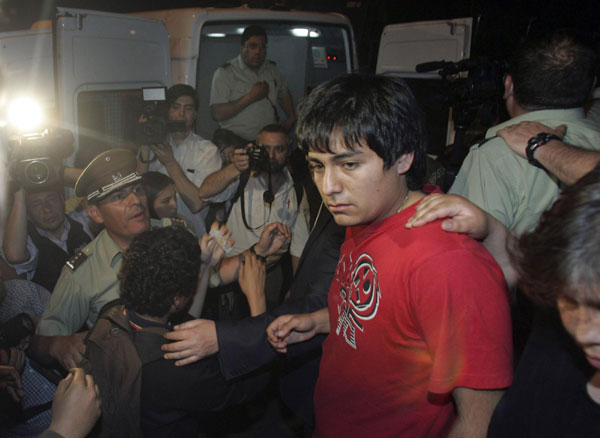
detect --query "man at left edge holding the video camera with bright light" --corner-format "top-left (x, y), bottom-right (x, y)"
top-left (3, 185), bottom-right (93, 291)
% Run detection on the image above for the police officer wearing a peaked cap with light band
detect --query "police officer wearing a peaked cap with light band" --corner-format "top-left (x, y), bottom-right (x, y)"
top-left (31, 149), bottom-right (150, 369)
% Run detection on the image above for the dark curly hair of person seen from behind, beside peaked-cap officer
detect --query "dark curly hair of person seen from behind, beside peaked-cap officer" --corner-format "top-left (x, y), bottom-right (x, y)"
top-left (118, 226), bottom-right (200, 317)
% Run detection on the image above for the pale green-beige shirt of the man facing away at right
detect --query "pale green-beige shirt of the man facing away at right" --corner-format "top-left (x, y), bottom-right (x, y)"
top-left (449, 108), bottom-right (600, 236)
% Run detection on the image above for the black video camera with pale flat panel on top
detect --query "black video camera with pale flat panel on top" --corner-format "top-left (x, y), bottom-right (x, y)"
top-left (136, 87), bottom-right (186, 144)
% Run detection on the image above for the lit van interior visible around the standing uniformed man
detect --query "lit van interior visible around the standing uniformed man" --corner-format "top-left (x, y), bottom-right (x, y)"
top-left (196, 21), bottom-right (353, 138)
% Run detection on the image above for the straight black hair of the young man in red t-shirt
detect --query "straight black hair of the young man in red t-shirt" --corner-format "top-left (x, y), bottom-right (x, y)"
top-left (296, 74), bottom-right (427, 190)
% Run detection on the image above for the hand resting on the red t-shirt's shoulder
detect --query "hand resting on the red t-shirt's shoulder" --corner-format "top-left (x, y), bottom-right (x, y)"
top-left (406, 193), bottom-right (489, 240)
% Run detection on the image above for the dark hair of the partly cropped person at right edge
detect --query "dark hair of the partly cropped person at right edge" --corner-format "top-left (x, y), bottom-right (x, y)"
top-left (511, 166), bottom-right (600, 305)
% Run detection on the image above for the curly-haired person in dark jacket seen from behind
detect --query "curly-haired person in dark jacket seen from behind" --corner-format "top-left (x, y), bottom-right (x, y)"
top-left (81, 226), bottom-right (263, 436)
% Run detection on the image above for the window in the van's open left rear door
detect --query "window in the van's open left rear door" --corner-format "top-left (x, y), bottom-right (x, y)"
top-left (75, 88), bottom-right (142, 168)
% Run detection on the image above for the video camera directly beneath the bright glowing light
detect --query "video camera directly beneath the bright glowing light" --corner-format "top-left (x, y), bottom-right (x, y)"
top-left (9, 129), bottom-right (73, 189)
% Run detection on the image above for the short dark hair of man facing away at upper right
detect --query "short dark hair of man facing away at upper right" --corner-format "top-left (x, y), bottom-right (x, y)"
top-left (510, 30), bottom-right (598, 111)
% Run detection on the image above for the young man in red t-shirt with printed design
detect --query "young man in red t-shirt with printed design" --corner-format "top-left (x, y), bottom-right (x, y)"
top-left (267, 75), bottom-right (512, 438)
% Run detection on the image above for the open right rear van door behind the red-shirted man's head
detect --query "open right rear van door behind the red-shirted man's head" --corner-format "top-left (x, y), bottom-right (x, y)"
top-left (376, 18), bottom-right (473, 155)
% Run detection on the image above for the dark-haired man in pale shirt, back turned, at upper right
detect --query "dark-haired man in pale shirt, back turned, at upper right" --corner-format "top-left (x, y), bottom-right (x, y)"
top-left (450, 32), bottom-right (600, 235)
